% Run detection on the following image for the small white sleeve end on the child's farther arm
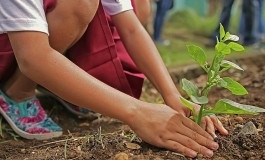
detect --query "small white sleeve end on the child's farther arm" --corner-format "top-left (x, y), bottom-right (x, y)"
top-left (101, 0), bottom-right (133, 15)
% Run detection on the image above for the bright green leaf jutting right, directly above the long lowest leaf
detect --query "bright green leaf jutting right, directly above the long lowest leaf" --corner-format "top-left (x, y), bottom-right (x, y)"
top-left (222, 77), bottom-right (248, 95)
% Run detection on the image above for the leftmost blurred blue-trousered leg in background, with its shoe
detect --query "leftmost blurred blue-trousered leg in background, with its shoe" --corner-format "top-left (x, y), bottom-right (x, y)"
top-left (153, 0), bottom-right (173, 45)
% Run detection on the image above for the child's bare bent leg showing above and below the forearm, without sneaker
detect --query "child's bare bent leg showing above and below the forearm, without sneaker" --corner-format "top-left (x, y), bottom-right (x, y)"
top-left (4, 0), bottom-right (99, 102)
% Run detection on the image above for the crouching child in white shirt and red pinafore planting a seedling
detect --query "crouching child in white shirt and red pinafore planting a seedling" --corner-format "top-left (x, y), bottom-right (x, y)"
top-left (0, 0), bottom-right (227, 157)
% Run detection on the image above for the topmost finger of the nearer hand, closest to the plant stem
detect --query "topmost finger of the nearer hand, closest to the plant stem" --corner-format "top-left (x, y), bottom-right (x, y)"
top-left (182, 117), bottom-right (213, 140)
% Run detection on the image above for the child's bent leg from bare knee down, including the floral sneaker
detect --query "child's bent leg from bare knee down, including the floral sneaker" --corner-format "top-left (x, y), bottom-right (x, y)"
top-left (0, 0), bottom-right (98, 139)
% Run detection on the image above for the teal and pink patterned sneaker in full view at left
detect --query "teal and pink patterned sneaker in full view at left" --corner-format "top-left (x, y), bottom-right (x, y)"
top-left (0, 90), bottom-right (62, 140)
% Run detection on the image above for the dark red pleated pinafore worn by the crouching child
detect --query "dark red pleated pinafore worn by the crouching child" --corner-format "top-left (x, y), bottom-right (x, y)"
top-left (0, 0), bottom-right (144, 98)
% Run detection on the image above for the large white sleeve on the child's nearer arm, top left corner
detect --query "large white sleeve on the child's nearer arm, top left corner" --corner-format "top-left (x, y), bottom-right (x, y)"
top-left (0, 0), bottom-right (48, 34)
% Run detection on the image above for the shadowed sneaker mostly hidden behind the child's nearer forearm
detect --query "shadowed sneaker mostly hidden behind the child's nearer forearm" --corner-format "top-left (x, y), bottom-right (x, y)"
top-left (37, 86), bottom-right (101, 120)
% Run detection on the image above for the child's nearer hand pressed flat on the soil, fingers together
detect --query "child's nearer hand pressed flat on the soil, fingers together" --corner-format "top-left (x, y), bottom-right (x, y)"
top-left (129, 103), bottom-right (218, 157)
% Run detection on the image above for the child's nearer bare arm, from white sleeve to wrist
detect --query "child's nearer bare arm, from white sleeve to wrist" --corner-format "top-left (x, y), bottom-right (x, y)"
top-left (8, 32), bottom-right (137, 123)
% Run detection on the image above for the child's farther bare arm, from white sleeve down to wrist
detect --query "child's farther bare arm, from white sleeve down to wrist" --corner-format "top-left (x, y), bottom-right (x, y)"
top-left (112, 11), bottom-right (182, 109)
